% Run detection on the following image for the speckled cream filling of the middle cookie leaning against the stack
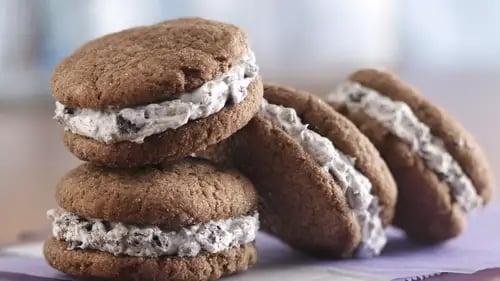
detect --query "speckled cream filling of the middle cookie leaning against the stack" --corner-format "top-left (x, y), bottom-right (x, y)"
top-left (260, 100), bottom-right (387, 257)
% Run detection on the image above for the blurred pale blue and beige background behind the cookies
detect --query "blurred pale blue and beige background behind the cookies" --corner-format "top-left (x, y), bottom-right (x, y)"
top-left (0, 0), bottom-right (500, 245)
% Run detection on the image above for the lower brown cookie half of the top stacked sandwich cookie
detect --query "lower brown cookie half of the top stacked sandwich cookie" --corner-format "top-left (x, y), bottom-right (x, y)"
top-left (64, 78), bottom-right (262, 167)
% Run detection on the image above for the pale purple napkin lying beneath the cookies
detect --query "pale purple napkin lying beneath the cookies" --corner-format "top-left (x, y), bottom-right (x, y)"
top-left (0, 204), bottom-right (500, 281)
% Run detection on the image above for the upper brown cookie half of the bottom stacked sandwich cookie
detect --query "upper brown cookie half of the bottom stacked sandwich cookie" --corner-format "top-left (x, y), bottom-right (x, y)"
top-left (56, 156), bottom-right (257, 226)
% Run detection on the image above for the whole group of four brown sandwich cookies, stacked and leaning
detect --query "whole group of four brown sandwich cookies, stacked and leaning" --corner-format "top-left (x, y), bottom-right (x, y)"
top-left (45, 15), bottom-right (492, 280)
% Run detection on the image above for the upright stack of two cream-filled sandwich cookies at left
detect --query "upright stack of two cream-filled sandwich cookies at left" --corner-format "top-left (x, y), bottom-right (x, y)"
top-left (44, 18), bottom-right (262, 280)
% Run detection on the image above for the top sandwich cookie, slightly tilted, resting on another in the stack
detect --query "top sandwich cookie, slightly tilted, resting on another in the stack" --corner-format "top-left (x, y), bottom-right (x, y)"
top-left (52, 18), bottom-right (262, 167)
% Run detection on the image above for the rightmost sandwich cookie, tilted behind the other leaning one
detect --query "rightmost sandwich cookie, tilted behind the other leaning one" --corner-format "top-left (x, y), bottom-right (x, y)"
top-left (327, 69), bottom-right (493, 242)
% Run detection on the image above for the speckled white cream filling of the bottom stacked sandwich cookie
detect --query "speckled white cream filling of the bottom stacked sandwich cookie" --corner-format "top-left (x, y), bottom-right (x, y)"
top-left (47, 208), bottom-right (259, 257)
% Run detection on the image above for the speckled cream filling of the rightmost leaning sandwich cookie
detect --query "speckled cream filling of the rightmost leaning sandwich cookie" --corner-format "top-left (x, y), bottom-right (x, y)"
top-left (328, 81), bottom-right (483, 212)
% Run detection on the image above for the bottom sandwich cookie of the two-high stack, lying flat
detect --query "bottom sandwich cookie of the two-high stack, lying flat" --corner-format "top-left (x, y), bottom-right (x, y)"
top-left (44, 159), bottom-right (259, 280)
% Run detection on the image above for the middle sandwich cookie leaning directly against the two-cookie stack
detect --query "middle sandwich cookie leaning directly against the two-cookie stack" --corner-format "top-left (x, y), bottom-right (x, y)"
top-left (201, 86), bottom-right (396, 257)
